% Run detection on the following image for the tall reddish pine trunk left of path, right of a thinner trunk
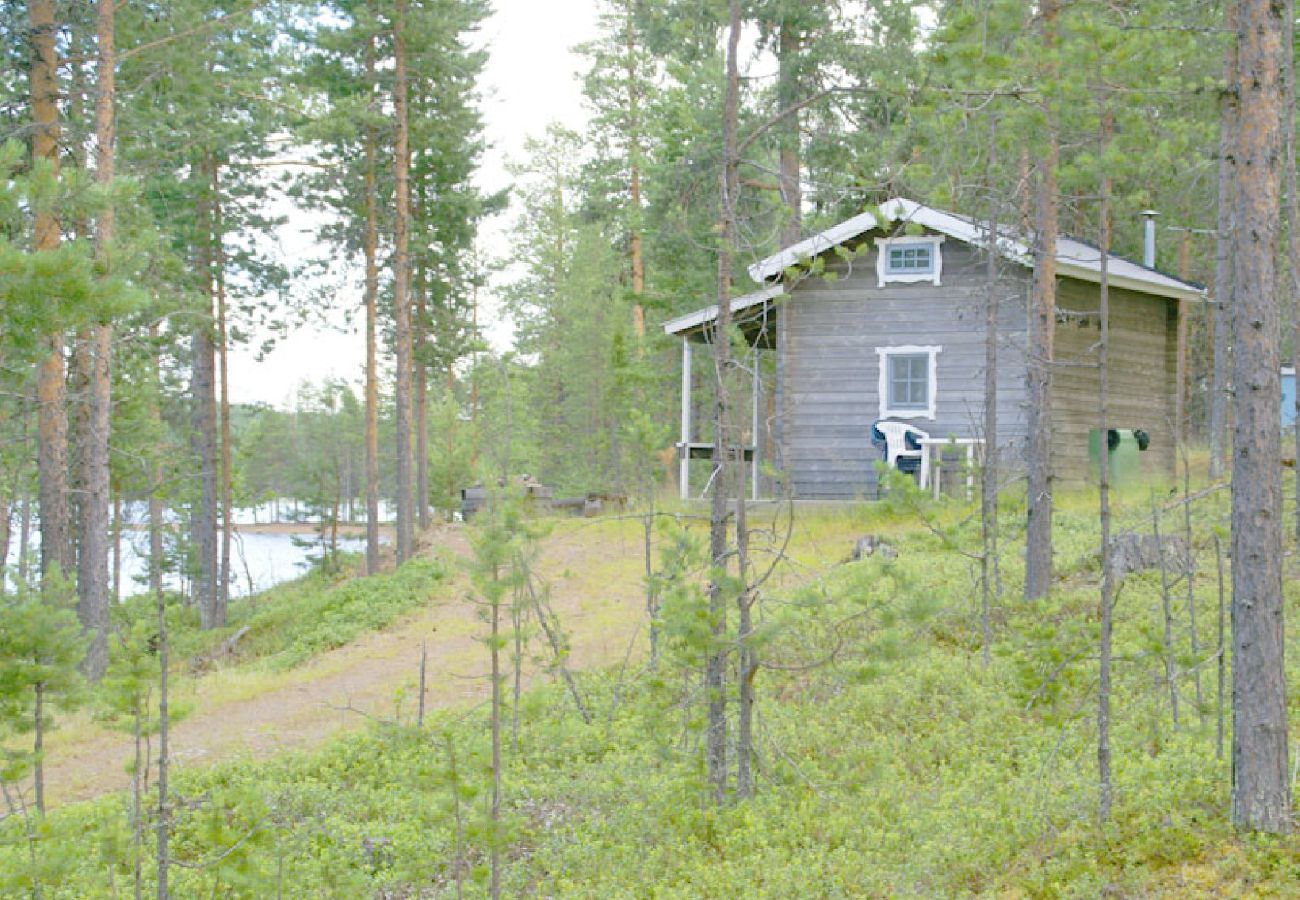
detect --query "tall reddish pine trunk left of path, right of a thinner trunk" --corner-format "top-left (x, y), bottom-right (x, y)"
top-left (393, 0), bottom-right (415, 566)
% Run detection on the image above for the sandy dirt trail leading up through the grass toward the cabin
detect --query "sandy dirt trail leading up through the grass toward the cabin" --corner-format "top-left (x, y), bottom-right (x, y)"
top-left (46, 523), bottom-right (644, 804)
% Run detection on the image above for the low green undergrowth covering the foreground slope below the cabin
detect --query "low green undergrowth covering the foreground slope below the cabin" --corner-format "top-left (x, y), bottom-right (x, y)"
top-left (0, 494), bottom-right (1300, 897)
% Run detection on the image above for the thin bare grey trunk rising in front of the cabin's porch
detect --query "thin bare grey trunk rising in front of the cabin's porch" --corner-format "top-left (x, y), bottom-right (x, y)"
top-left (705, 0), bottom-right (741, 805)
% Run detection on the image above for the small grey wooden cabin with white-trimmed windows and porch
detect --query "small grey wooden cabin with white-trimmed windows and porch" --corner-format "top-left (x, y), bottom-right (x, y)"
top-left (663, 199), bottom-right (1204, 501)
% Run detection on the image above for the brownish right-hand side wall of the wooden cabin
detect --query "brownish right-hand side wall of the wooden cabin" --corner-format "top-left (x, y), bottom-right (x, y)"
top-left (1052, 278), bottom-right (1178, 485)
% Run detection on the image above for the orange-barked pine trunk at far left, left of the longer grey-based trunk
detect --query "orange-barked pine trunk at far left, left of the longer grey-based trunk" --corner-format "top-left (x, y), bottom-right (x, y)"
top-left (27, 0), bottom-right (73, 576)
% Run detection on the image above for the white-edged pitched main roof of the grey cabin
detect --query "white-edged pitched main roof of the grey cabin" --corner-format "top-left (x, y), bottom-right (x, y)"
top-left (749, 198), bottom-right (1205, 300)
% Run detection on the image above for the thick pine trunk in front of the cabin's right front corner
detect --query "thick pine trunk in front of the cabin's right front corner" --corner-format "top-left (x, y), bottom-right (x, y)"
top-left (1024, 0), bottom-right (1058, 600)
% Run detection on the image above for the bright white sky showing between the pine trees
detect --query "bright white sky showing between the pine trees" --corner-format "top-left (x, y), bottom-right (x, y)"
top-left (230, 0), bottom-right (597, 406)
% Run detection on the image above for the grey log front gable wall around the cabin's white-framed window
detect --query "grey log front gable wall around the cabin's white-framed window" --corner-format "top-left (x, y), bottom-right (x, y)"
top-left (783, 235), bottom-right (1029, 499)
